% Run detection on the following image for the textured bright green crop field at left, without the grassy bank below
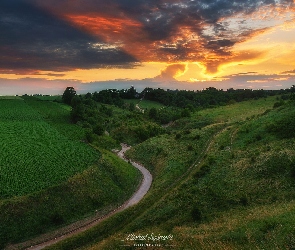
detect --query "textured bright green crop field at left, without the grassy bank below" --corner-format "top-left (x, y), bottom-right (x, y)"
top-left (0, 99), bottom-right (99, 199)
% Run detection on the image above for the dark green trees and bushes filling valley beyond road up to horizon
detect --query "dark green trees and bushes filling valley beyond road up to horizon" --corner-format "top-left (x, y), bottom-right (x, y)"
top-left (62, 85), bottom-right (295, 146)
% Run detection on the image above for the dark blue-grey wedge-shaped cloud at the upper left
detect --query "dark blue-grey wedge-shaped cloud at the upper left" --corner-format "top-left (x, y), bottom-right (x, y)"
top-left (0, 0), bottom-right (135, 70)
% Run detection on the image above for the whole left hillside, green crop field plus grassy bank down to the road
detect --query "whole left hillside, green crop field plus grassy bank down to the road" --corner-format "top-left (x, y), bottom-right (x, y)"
top-left (0, 97), bottom-right (140, 249)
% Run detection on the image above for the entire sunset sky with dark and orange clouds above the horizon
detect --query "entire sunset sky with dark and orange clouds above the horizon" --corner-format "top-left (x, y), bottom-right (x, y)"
top-left (0, 0), bottom-right (295, 95)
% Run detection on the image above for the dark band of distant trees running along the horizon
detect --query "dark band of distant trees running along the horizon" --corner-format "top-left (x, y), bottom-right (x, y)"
top-left (63, 85), bottom-right (295, 108)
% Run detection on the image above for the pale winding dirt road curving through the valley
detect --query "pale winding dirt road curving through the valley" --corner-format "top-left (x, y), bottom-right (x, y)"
top-left (6, 144), bottom-right (153, 250)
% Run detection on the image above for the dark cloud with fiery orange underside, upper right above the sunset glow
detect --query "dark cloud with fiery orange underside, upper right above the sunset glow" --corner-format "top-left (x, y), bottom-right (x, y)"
top-left (115, 0), bottom-right (293, 70)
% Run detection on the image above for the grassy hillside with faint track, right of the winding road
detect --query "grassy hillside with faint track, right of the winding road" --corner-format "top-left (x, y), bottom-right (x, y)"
top-left (45, 97), bottom-right (295, 249)
